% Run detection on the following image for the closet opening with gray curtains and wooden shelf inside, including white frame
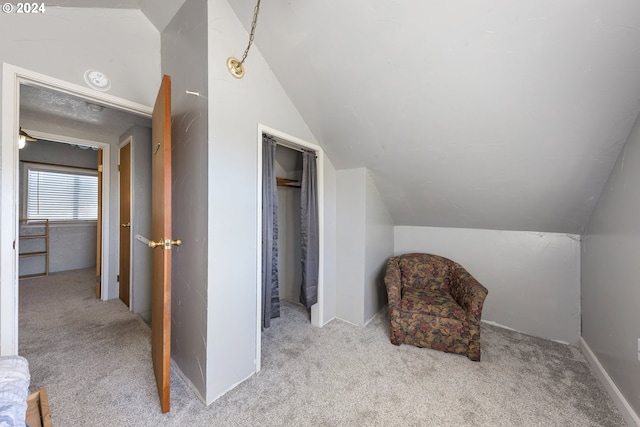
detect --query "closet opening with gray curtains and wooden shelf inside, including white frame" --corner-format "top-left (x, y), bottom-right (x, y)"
top-left (256, 126), bottom-right (324, 371)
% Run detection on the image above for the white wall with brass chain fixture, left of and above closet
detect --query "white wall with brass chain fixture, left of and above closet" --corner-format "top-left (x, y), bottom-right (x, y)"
top-left (205, 0), bottom-right (335, 402)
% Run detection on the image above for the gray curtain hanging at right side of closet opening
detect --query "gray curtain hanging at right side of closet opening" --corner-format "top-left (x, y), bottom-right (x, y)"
top-left (300, 151), bottom-right (319, 308)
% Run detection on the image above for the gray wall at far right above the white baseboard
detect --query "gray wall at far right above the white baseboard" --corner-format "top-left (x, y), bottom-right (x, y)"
top-left (582, 111), bottom-right (640, 414)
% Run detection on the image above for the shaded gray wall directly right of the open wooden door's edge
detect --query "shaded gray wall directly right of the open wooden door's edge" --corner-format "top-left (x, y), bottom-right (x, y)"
top-left (162, 0), bottom-right (209, 399)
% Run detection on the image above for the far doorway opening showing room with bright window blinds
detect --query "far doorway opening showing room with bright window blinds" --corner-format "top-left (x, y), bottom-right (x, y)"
top-left (17, 134), bottom-right (104, 282)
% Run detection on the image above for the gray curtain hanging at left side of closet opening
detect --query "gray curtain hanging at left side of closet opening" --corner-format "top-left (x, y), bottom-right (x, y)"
top-left (262, 134), bottom-right (280, 329)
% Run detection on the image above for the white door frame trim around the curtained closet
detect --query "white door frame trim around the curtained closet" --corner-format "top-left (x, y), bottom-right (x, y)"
top-left (256, 123), bottom-right (325, 372)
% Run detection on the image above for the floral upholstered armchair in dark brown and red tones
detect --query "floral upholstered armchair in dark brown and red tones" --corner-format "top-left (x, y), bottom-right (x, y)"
top-left (384, 253), bottom-right (488, 361)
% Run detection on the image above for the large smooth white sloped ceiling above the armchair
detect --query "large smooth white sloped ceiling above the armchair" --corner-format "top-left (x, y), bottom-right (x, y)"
top-left (229, 0), bottom-right (640, 233)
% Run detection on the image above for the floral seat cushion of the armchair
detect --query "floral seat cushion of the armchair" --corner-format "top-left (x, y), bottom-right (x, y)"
top-left (401, 288), bottom-right (467, 320)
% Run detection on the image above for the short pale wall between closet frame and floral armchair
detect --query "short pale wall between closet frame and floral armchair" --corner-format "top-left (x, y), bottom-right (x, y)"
top-left (336, 168), bottom-right (394, 326)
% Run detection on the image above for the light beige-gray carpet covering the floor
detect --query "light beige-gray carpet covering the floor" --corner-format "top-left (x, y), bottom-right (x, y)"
top-left (20, 270), bottom-right (626, 427)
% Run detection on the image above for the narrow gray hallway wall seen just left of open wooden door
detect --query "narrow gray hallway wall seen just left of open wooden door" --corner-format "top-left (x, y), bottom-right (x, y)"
top-left (118, 126), bottom-right (152, 322)
